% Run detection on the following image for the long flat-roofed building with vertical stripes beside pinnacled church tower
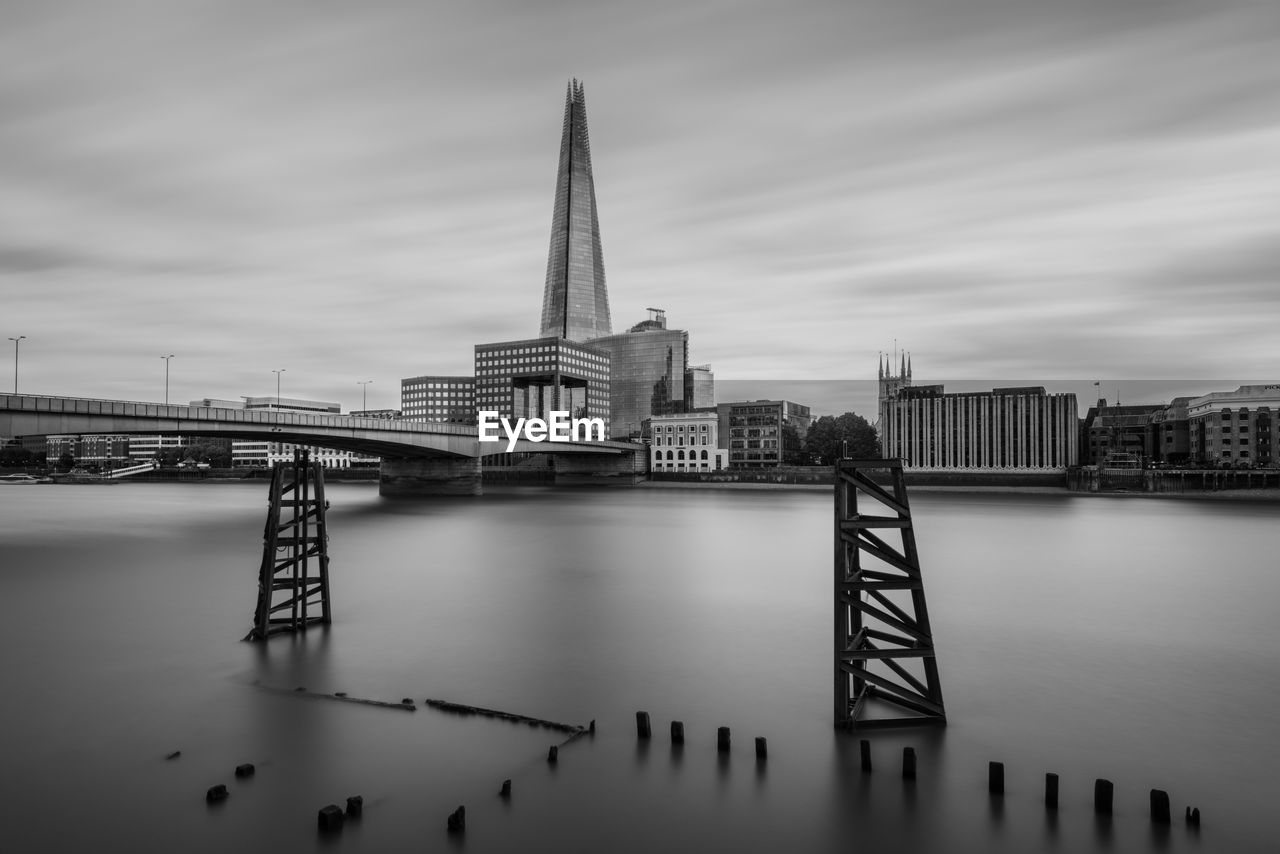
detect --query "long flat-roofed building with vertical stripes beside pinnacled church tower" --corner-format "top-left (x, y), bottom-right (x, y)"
top-left (879, 357), bottom-right (1079, 471)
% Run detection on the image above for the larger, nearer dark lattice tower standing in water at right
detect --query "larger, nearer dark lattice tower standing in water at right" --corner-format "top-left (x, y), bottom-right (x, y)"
top-left (835, 460), bottom-right (947, 729)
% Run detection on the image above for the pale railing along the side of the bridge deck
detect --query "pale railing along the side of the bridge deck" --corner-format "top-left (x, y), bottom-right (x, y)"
top-left (0, 394), bottom-right (476, 437)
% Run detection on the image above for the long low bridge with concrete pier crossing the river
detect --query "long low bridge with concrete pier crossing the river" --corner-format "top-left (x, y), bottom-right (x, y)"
top-left (0, 394), bottom-right (648, 495)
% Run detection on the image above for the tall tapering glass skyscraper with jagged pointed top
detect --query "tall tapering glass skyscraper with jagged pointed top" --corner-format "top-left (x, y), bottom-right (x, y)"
top-left (539, 79), bottom-right (613, 341)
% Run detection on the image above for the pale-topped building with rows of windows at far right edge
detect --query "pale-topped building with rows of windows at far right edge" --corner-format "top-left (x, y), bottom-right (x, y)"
top-left (1187, 384), bottom-right (1280, 469)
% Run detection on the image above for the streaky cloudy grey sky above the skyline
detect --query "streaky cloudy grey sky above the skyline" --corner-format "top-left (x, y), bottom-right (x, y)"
top-left (0, 0), bottom-right (1280, 411)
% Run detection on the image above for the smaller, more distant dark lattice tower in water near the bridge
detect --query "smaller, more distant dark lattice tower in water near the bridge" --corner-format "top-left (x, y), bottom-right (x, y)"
top-left (244, 451), bottom-right (330, 640)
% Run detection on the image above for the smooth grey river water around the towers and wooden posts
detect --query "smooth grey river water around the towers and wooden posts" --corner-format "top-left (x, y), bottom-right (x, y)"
top-left (0, 484), bottom-right (1280, 854)
